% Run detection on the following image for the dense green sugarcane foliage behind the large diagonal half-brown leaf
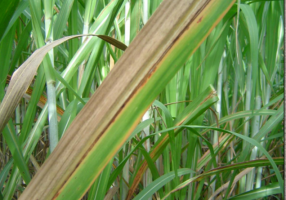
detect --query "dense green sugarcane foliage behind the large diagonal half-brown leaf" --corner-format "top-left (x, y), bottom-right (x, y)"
top-left (0, 0), bottom-right (284, 200)
